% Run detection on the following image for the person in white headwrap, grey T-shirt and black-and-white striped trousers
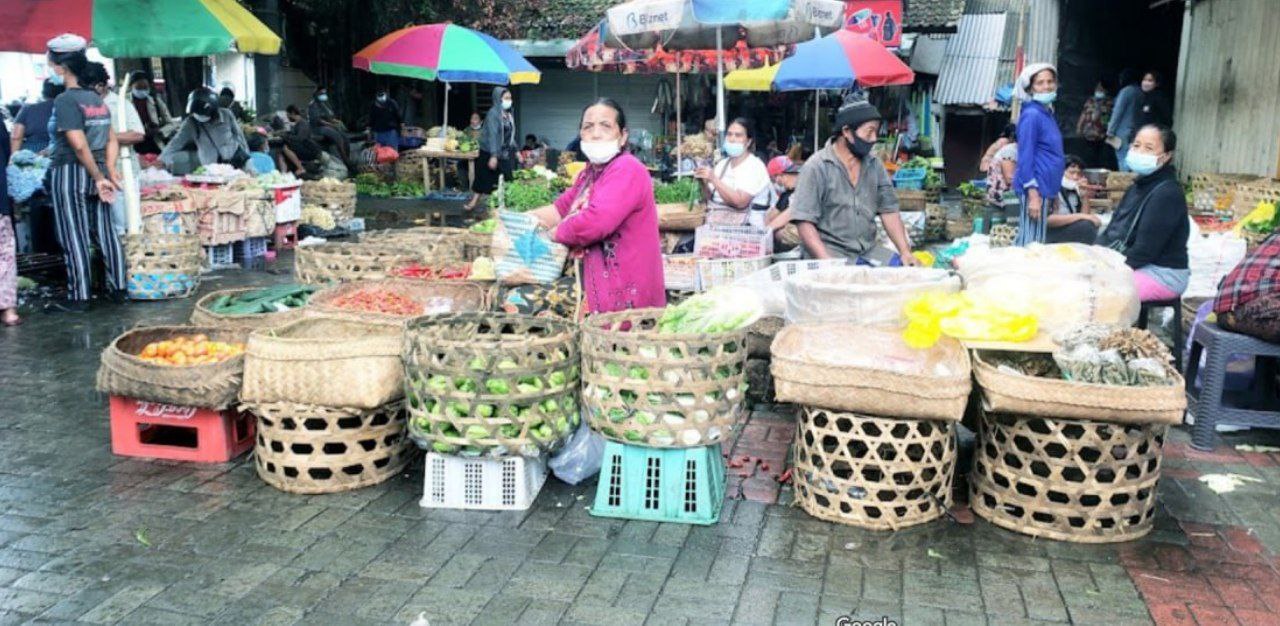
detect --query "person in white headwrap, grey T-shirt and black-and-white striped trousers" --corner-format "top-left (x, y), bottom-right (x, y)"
top-left (46, 35), bottom-right (125, 312)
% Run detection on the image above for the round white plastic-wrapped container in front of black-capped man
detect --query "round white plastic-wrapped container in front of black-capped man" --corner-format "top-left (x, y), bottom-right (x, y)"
top-left (783, 266), bottom-right (960, 328)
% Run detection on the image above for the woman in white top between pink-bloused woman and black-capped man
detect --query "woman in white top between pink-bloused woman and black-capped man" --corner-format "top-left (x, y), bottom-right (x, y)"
top-left (694, 118), bottom-right (771, 229)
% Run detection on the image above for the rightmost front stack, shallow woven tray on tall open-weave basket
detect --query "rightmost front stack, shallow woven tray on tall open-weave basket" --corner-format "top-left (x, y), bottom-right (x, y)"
top-left (969, 351), bottom-right (1187, 543)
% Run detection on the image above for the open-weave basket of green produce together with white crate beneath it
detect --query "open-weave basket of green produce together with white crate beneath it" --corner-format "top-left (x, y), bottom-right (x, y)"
top-left (403, 312), bottom-right (580, 510)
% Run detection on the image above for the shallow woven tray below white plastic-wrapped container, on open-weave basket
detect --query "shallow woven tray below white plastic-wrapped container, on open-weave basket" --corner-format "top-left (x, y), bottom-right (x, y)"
top-left (771, 324), bottom-right (972, 421)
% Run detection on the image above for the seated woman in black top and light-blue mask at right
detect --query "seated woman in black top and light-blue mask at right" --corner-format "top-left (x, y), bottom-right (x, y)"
top-left (1097, 125), bottom-right (1190, 302)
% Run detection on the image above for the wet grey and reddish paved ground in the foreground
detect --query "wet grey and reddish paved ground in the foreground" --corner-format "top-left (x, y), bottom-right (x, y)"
top-left (0, 256), bottom-right (1280, 626)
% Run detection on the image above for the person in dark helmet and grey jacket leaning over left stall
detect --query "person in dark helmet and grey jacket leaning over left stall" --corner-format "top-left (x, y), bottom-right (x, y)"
top-left (160, 87), bottom-right (248, 173)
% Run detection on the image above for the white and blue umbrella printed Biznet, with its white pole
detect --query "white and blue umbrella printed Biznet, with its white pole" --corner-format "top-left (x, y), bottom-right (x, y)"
top-left (602, 0), bottom-right (845, 134)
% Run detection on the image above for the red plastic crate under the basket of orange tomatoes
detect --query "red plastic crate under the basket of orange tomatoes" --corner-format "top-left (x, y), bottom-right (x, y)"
top-left (111, 396), bottom-right (256, 463)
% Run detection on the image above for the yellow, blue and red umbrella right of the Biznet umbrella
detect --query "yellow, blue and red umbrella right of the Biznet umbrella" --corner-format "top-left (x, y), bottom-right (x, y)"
top-left (724, 31), bottom-right (915, 151)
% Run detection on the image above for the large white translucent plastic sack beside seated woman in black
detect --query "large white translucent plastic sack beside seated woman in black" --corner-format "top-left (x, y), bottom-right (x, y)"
top-left (955, 243), bottom-right (1140, 334)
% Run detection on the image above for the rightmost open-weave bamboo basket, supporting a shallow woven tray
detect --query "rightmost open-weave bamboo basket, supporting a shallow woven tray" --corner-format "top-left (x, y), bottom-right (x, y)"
top-left (969, 413), bottom-right (1167, 543)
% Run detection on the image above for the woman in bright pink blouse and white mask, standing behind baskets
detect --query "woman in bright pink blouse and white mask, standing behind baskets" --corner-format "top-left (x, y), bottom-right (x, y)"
top-left (535, 99), bottom-right (667, 312)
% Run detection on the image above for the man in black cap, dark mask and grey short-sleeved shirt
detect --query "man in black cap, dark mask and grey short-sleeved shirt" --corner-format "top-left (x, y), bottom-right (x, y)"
top-left (791, 93), bottom-right (919, 265)
